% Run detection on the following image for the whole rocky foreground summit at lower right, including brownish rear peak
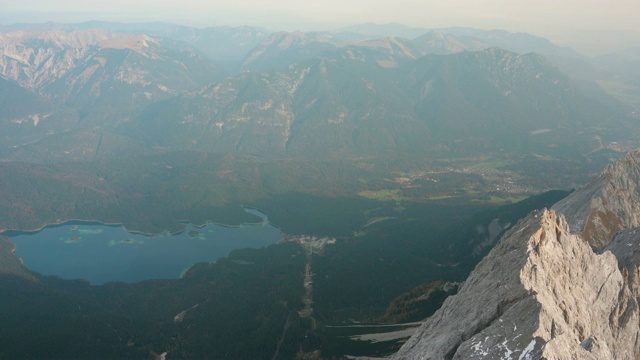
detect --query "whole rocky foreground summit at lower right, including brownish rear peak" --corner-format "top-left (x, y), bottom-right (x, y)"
top-left (393, 150), bottom-right (640, 359)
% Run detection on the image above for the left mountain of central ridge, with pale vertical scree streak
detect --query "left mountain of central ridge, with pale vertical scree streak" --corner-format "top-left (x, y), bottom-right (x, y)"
top-left (127, 59), bottom-right (424, 156)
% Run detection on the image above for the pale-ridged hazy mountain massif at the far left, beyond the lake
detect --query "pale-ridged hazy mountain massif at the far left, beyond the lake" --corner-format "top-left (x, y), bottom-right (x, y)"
top-left (0, 30), bottom-right (225, 126)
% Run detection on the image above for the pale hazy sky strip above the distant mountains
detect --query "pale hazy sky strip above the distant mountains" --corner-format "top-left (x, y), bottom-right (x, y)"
top-left (0, 0), bottom-right (640, 51)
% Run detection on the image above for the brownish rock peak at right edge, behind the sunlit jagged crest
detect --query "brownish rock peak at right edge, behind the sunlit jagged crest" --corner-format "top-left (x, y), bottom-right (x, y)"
top-left (553, 149), bottom-right (640, 249)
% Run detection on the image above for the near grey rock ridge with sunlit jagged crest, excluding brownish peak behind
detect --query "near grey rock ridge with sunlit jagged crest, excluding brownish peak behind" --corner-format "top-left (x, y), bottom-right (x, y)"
top-left (393, 209), bottom-right (640, 359)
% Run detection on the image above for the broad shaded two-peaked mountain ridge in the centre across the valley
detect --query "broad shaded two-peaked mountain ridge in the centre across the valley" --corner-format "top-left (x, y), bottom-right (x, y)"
top-left (127, 48), bottom-right (634, 156)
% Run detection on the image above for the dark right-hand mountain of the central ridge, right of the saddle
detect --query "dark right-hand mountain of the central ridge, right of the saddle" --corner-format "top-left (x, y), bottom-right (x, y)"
top-left (407, 48), bottom-right (630, 154)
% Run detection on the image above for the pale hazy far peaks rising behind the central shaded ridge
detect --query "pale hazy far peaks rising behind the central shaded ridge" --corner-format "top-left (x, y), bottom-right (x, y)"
top-left (236, 27), bottom-right (584, 71)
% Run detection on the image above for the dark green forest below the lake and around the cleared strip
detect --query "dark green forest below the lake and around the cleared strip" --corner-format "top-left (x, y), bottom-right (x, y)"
top-left (0, 183), bottom-right (566, 358)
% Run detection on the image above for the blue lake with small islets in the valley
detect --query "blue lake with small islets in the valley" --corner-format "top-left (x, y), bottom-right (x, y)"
top-left (3, 209), bottom-right (282, 285)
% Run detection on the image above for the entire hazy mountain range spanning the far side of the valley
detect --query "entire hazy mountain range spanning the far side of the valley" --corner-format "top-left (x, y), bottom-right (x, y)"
top-left (0, 22), bottom-right (637, 160)
